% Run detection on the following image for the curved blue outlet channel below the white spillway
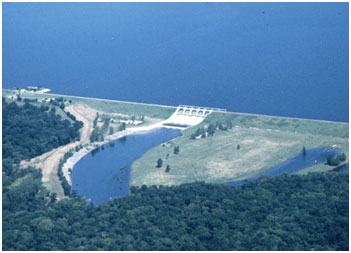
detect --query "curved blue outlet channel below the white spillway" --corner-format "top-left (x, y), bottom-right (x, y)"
top-left (71, 128), bottom-right (182, 204)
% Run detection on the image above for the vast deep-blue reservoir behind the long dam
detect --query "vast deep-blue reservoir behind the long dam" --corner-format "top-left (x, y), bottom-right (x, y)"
top-left (3, 3), bottom-right (349, 121)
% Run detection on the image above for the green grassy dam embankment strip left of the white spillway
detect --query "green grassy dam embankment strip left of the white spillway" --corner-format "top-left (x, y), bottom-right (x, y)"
top-left (8, 89), bottom-right (176, 119)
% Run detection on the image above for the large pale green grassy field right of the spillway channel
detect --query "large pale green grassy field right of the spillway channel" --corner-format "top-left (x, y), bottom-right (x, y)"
top-left (131, 113), bottom-right (348, 186)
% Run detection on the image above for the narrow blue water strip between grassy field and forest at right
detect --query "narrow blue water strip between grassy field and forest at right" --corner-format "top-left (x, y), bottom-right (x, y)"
top-left (227, 148), bottom-right (348, 186)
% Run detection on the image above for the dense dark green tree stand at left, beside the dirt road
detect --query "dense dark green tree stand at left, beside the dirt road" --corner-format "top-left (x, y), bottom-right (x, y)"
top-left (2, 99), bottom-right (82, 162)
